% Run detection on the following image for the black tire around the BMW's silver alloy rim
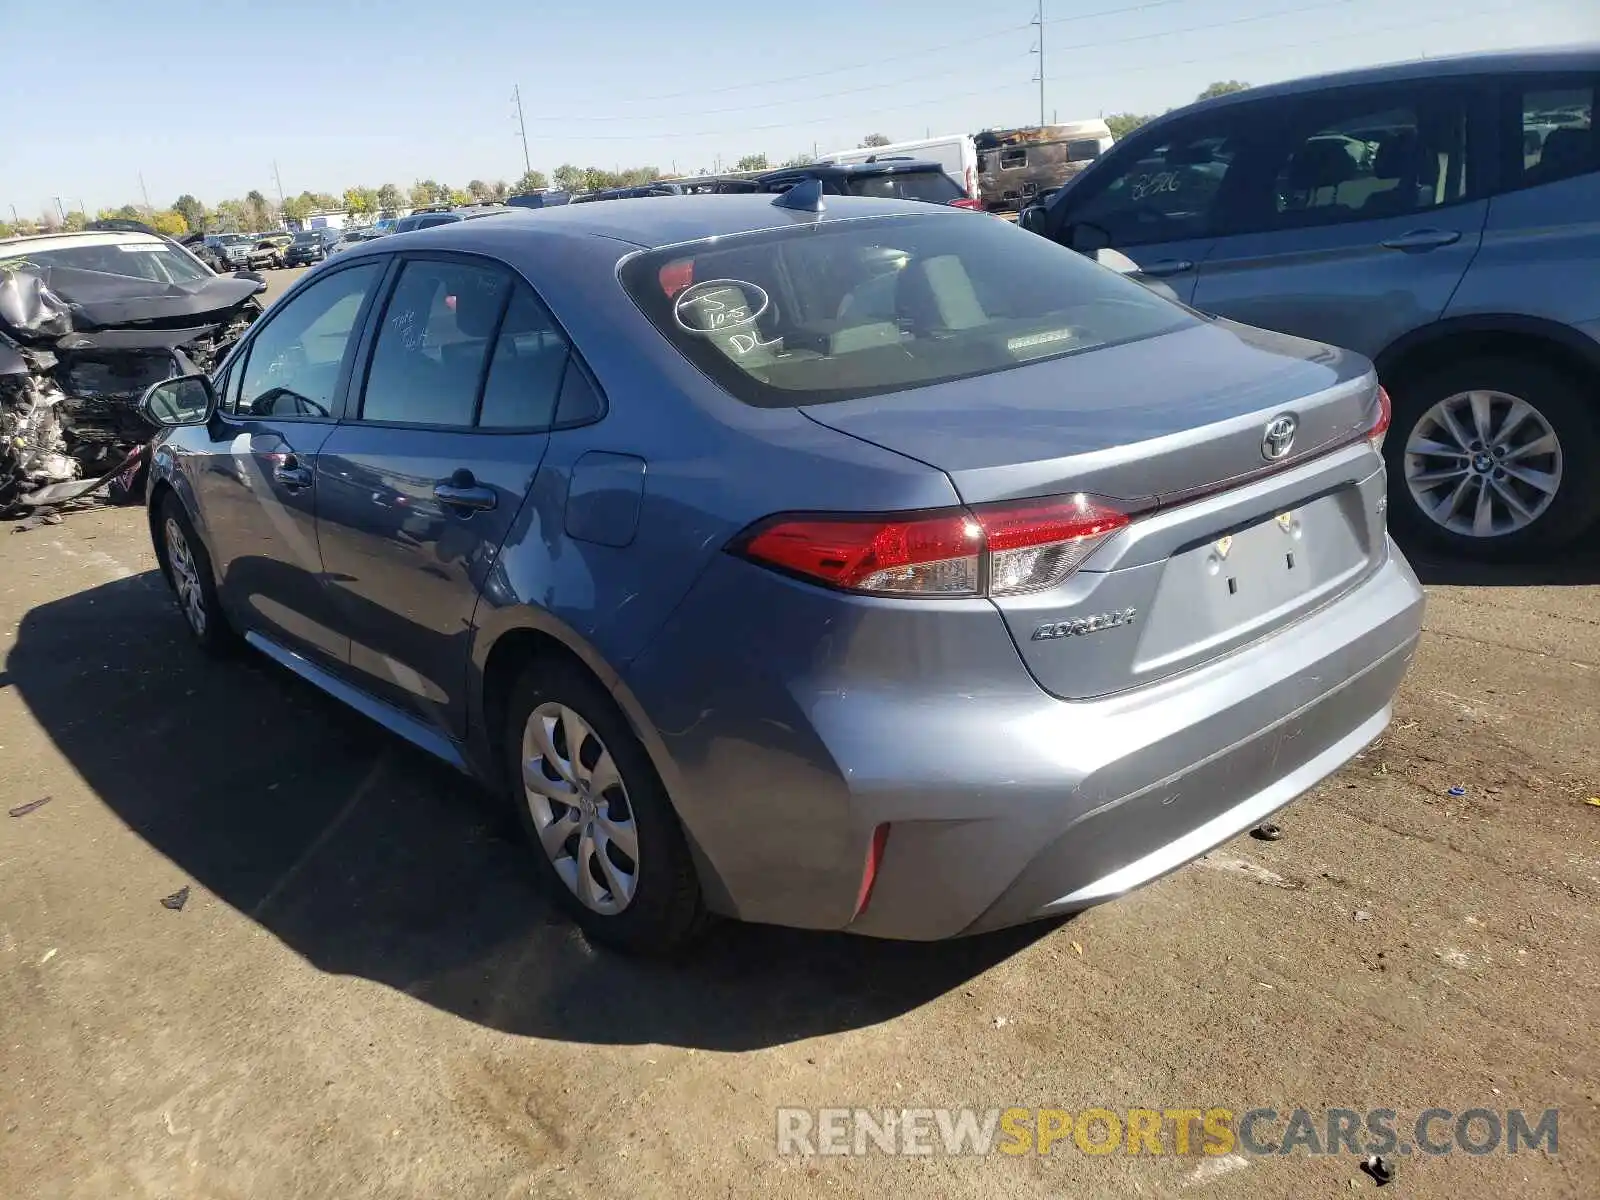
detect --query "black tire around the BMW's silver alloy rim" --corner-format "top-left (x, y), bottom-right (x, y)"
top-left (1384, 357), bottom-right (1600, 562)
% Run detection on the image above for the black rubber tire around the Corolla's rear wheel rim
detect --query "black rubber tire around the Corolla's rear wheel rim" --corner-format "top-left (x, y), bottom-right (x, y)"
top-left (502, 659), bottom-right (707, 957)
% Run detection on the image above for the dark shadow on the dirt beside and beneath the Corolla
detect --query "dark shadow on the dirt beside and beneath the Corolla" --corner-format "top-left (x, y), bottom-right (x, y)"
top-left (8, 571), bottom-right (1051, 1050)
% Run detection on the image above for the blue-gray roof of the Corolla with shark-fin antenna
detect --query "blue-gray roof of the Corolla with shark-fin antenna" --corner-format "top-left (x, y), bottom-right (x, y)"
top-left (347, 192), bottom-right (947, 261)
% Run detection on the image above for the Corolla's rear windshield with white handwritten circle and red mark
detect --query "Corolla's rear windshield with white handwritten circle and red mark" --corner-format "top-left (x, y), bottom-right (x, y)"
top-left (621, 211), bottom-right (1197, 408)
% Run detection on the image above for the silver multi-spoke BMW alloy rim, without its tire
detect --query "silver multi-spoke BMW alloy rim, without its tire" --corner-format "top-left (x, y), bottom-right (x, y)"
top-left (1405, 390), bottom-right (1562, 538)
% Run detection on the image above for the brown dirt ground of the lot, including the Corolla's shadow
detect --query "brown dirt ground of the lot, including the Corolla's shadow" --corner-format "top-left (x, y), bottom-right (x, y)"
top-left (0, 324), bottom-right (1600, 1200)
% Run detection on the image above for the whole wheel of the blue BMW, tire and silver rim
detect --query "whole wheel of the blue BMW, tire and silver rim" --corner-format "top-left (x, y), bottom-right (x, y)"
top-left (1384, 358), bottom-right (1600, 560)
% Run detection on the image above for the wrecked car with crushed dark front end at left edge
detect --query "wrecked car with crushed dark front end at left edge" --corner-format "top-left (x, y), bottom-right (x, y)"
top-left (0, 230), bottom-right (266, 515)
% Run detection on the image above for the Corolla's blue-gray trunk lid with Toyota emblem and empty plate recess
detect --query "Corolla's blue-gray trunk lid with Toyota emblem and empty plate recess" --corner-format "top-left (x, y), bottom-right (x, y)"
top-left (803, 322), bottom-right (1386, 699)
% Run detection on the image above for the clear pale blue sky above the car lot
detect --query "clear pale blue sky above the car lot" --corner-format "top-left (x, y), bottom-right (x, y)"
top-left (0, 0), bottom-right (1600, 218)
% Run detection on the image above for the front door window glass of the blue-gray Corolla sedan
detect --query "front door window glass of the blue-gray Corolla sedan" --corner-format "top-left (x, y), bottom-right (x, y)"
top-left (226, 262), bottom-right (382, 419)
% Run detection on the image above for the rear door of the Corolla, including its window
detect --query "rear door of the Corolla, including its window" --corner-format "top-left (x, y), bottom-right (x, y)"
top-left (317, 253), bottom-right (566, 738)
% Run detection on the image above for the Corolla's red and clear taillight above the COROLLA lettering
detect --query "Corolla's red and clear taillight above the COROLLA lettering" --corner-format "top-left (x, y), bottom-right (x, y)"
top-left (738, 494), bottom-right (1128, 597)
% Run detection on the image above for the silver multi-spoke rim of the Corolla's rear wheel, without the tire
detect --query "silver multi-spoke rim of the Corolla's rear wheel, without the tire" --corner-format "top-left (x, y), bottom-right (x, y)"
top-left (522, 701), bottom-right (638, 917)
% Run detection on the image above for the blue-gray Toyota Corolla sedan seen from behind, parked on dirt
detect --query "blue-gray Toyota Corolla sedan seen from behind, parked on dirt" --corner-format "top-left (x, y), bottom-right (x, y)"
top-left (131, 187), bottom-right (1422, 950)
